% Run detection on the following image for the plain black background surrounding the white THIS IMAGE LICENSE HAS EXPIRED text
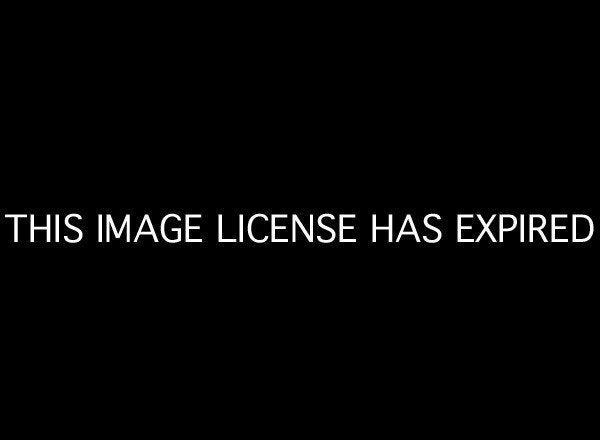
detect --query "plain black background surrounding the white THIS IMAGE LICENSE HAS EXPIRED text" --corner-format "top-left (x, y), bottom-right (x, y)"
top-left (1, 5), bottom-right (598, 433)
